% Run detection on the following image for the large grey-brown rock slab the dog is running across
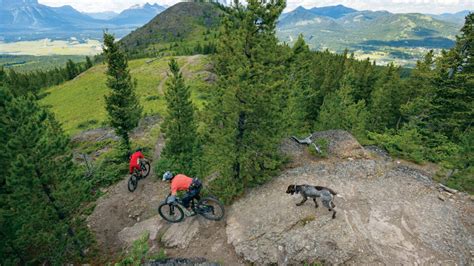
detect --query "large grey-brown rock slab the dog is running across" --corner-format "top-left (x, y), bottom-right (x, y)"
top-left (226, 131), bottom-right (474, 265)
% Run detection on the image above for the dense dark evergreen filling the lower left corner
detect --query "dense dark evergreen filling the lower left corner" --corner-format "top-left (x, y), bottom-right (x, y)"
top-left (0, 89), bottom-right (91, 264)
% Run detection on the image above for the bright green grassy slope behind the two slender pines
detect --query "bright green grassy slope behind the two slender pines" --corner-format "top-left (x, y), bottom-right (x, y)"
top-left (42, 56), bottom-right (209, 134)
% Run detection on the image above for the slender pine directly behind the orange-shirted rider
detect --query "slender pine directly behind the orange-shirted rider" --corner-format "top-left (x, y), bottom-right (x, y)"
top-left (160, 59), bottom-right (198, 175)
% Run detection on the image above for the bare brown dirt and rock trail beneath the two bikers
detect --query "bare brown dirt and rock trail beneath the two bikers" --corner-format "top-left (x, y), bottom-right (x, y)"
top-left (88, 129), bottom-right (243, 265)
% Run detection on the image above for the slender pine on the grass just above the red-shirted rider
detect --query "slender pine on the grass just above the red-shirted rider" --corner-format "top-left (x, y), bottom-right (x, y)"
top-left (104, 33), bottom-right (143, 155)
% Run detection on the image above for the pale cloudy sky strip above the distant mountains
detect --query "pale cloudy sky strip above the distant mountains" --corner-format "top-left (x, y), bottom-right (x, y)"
top-left (39, 0), bottom-right (474, 14)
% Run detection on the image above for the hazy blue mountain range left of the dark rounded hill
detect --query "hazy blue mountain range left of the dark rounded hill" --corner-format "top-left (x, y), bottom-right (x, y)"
top-left (0, 0), bottom-right (165, 41)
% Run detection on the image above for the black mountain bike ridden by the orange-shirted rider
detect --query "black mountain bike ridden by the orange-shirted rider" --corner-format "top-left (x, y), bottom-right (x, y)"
top-left (158, 195), bottom-right (224, 223)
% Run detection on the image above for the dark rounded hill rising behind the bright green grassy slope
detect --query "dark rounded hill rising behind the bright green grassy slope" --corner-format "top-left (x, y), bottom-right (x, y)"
top-left (120, 3), bottom-right (222, 55)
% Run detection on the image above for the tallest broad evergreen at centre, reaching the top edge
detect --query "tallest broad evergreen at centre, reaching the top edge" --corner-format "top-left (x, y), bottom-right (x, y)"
top-left (203, 0), bottom-right (287, 201)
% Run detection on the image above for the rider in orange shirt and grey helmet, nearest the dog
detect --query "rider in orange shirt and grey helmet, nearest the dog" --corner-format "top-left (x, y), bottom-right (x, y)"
top-left (163, 171), bottom-right (202, 213)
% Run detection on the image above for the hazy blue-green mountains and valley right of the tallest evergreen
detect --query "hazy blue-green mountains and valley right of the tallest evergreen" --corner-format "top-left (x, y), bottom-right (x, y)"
top-left (277, 5), bottom-right (468, 55)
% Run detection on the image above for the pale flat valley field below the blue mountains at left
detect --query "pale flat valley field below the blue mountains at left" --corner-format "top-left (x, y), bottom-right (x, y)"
top-left (0, 39), bottom-right (102, 56)
